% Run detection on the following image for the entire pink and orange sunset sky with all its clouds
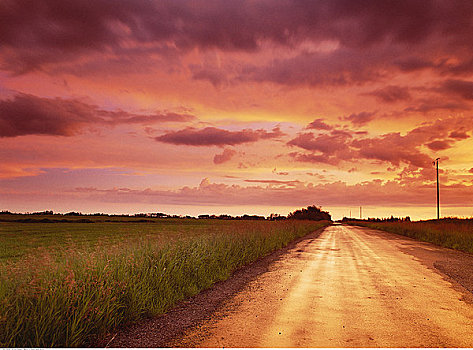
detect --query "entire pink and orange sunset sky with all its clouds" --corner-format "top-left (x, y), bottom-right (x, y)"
top-left (0, 0), bottom-right (473, 219)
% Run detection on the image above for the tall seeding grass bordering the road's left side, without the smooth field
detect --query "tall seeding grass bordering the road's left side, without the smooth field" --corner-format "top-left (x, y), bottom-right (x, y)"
top-left (0, 221), bottom-right (328, 347)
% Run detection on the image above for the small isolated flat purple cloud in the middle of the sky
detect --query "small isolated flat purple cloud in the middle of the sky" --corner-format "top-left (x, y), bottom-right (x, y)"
top-left (155, 127), bottom-right (285, 146)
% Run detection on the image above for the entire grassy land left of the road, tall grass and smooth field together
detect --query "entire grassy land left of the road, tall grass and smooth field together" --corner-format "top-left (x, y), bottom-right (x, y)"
top-left (0, 215), bottom-right (328, 347)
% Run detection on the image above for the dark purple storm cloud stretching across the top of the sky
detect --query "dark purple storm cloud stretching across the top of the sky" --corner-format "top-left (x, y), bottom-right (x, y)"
top-left (0, 0), bottom-right (473, 78)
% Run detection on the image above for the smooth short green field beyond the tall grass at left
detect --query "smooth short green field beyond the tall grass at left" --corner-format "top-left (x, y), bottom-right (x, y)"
top-left (0, 215), bottom-right (219, 264)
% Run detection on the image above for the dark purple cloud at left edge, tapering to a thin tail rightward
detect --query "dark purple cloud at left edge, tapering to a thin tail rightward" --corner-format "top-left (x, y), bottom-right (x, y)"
top-left (0, 94), bottom-right (196, 137)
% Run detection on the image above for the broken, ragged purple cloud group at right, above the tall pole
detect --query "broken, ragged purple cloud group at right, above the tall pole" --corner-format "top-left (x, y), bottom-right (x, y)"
top-left (288, 117), bottom-right (473, 168)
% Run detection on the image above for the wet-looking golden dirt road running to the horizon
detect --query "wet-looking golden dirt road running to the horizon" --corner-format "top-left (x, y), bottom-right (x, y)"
top-left (170, 225), bottom-right (473, 347)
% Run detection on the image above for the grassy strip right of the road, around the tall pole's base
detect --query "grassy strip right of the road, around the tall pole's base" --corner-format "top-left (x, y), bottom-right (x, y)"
top-left (346, 218), bottom-right (473, 253)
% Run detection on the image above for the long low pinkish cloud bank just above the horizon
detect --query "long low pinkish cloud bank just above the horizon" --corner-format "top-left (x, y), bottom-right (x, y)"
top-left (67, 178), bottom-right (473, 207)
